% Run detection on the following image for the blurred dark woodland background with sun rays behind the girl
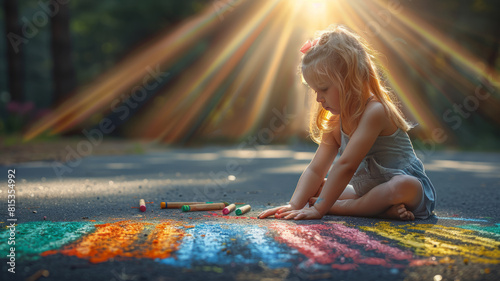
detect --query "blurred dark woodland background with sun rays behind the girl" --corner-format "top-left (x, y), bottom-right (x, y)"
top-left (0, 0), bottom-right (500, 155)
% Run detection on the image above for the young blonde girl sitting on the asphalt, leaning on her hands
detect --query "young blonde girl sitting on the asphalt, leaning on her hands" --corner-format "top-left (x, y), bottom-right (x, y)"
top-left (259, 26), bottom-right (436, 220)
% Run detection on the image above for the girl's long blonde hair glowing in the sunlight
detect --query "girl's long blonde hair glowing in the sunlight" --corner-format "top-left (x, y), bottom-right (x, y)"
top-left (299, 26), bottom-right (411, 144)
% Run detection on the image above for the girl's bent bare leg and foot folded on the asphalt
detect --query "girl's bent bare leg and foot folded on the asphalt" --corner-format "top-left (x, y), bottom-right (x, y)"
top-left (328, 175), bottom-right (423, 219)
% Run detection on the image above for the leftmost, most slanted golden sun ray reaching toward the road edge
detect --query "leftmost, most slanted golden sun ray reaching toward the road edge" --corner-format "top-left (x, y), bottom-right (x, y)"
top-left (24, 1), bottom-right (246, 140)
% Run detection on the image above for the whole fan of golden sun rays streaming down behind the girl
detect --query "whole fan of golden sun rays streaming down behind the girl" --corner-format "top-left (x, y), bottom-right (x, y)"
top-left (24, 0), bottom-right (500, 143)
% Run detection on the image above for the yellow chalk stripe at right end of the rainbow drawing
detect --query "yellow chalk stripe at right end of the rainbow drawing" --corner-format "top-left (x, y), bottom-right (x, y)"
top-left (360, 222), bottom-right (500, 264)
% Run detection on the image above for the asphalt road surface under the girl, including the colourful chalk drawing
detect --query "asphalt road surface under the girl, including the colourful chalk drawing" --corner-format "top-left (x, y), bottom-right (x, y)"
top-left (0, 146), bottom-right (500, 280)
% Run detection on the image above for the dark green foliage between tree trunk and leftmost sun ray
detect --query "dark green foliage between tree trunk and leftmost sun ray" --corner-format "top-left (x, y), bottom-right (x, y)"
top-left (70, 0), bottom-right (206, 84)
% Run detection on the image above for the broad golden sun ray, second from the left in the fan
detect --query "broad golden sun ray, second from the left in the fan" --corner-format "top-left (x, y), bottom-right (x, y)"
top-left (135, 1), bottom-right (277, 142)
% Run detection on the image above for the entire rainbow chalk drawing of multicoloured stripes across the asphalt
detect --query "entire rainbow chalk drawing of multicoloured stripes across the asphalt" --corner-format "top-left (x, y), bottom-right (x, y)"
top-left (0, 217), bottom-right (500, 272)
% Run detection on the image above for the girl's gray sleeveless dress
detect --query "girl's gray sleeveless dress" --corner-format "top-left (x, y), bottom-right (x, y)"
top-left (339, 125), bottom-right (436, 219)
